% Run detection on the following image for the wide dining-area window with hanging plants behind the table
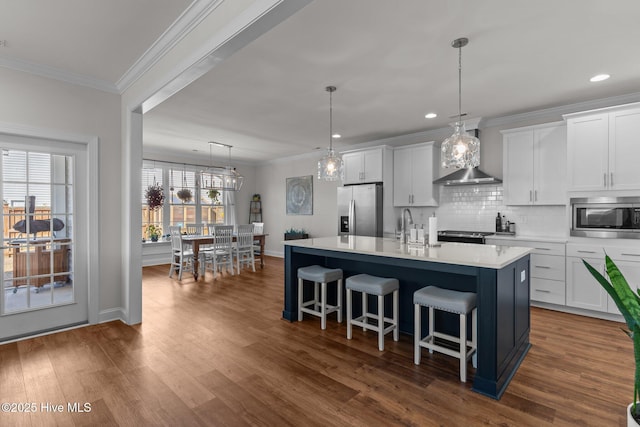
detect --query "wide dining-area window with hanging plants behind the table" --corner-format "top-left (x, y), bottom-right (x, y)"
top-left (141, 161), bottom-right (226, 240)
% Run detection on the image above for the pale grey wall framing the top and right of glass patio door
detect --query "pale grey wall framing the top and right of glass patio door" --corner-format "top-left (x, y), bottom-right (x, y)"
top-left (0, 67), bottom-right (122, 312)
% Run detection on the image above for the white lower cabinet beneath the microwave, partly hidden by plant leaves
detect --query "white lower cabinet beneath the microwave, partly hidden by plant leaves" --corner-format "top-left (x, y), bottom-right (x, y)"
top-left (567, 244), bottom-right (640, 314)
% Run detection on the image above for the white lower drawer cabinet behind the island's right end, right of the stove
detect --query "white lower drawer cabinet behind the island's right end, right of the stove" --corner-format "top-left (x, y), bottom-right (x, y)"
top-left (486, 238), bottom-right (565, 305)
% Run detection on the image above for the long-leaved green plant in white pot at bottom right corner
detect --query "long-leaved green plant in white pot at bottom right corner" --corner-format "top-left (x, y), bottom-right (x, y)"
top-left (582, 254), bottom-right (640, 426)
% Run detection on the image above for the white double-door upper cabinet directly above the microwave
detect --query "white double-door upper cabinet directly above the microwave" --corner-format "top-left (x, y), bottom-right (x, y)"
top-left (564, 104), bottom-right (640, 191)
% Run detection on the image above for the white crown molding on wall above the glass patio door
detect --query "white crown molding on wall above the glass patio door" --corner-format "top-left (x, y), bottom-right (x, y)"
top-left (0, 55), bottom-right (120, 95)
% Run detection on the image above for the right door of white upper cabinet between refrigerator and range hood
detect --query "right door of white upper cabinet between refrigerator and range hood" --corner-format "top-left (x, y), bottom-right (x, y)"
top-left (410, 144), bottom-right (438, 206)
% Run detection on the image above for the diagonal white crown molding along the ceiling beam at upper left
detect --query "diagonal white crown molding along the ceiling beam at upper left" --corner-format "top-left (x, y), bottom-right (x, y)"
top-left (115, 0), bottom-right (224, 93)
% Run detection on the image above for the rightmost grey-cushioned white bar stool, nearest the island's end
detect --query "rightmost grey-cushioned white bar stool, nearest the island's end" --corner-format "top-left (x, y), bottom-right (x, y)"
top-left (413, 286), bottom-right (478, 383)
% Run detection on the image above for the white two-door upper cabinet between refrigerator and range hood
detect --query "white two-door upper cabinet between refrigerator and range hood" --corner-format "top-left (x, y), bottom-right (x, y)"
top-left (393, 142), bottom-right (438, 206)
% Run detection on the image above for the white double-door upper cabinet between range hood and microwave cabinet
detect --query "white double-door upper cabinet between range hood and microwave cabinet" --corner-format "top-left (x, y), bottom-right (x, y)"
top-left (502, 122), bottom-right (567, 205)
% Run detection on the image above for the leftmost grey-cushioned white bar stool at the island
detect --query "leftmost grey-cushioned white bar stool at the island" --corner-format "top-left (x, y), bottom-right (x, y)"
top-left (298, 265), bottom-right (342, 329)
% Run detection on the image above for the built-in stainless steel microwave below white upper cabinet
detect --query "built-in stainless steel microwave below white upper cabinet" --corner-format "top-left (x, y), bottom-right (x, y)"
top-left (570, 197), bottom-right (640, 239)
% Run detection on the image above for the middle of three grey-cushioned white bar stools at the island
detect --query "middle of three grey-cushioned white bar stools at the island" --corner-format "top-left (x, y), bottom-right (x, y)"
top-left (346, 274), bottom-right (400, 351)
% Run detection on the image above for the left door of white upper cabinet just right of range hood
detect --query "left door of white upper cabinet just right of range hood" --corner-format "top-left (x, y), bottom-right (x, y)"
top-left (503, 130), bottom-right (533, 205)
